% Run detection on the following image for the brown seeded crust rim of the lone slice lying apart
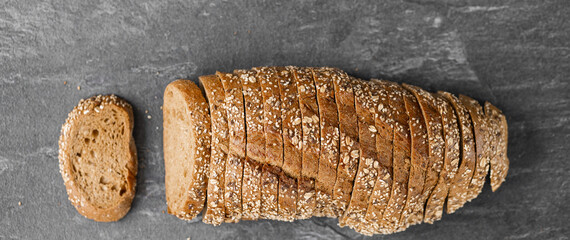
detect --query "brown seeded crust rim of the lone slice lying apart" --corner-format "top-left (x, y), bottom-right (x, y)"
top-left (58, 95), bottom-right (137, 222)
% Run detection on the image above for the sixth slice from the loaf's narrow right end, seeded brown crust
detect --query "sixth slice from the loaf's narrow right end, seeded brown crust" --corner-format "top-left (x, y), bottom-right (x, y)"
top-left (398, 88), bottom-right (429, 231)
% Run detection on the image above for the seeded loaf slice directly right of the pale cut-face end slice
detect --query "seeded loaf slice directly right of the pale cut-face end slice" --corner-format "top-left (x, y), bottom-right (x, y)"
top-left (198, 75), bottom-right (229, 226)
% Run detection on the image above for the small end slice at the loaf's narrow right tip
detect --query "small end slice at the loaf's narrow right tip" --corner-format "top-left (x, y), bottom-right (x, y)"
top-left (485, 102), bottom-right (509, 192)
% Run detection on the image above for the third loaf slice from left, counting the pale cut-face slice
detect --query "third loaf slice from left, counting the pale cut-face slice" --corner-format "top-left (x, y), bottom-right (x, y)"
top-left (216, 72), bottom-right (246, 222)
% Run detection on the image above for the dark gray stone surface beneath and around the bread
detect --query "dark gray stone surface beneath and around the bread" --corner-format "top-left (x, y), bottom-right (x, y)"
top-left (0, 0), bottom-right (570, 239)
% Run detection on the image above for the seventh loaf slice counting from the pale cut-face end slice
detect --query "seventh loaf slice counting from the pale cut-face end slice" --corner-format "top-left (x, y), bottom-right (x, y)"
top-left (287, 66), bottom-right (320, 219)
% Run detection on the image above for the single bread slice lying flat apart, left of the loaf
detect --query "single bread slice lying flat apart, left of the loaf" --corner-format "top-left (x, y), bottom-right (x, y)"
top-left (59, 95), bottom-right (137, 222)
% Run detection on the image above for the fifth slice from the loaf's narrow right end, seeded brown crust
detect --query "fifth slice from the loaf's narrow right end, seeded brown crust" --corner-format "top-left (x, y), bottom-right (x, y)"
top-left (403, 84), bottom-right (445, 224)
